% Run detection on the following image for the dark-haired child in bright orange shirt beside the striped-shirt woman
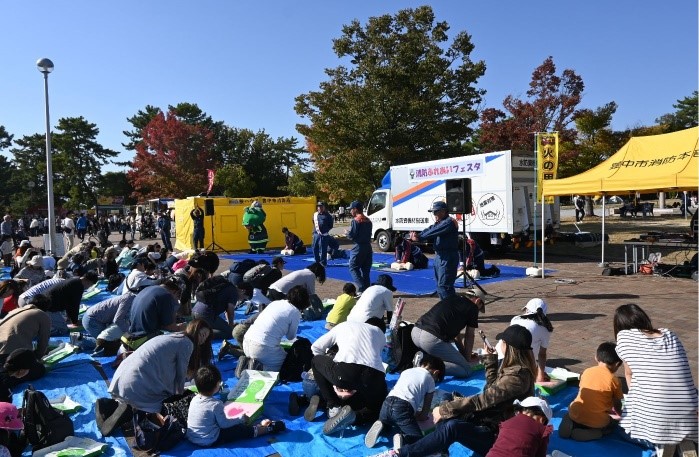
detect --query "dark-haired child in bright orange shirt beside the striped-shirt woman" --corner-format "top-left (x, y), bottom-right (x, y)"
top-left (558, 343), bottom-right (623, 441)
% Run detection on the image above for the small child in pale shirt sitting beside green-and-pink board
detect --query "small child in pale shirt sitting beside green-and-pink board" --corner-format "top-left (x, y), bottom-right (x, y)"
top-left (187, 365), bottom-right (286, 446)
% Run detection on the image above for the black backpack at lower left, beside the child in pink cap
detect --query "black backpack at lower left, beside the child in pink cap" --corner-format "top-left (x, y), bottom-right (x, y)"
top-left (22, 385), bottom-right (73, 452)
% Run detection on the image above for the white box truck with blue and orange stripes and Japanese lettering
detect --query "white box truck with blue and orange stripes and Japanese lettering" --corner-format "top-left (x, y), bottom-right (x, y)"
top-left (366, 151), bottom-right (560, 252)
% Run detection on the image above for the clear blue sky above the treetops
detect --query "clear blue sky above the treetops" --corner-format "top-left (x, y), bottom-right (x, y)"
top-left (0, 0), bottom-right (698, 170)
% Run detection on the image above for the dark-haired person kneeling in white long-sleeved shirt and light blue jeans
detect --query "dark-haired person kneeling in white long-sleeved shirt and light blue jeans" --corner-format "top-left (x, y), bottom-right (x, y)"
top-left (238, 286), bottom-right (310, 371)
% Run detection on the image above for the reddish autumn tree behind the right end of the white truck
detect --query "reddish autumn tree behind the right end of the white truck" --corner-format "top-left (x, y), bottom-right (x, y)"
top-left (479, 57), bottom-right (585, 152)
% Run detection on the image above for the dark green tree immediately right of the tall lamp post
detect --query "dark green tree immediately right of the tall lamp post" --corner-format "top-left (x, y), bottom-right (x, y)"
top-left (51, 116), bottom-right (118, 209)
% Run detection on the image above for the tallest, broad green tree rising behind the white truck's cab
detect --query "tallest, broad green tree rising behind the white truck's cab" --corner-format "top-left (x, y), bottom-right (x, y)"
top-left (295, 6), bottom-right (485, 200)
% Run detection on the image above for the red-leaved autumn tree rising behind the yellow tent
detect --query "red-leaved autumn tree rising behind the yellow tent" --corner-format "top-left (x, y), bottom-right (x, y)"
top-left (128, 110), bottom-right (216, 199)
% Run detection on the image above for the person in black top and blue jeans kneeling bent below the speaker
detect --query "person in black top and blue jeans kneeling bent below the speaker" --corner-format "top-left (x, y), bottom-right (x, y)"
top-left (410, 295), bottom-right (485, 378)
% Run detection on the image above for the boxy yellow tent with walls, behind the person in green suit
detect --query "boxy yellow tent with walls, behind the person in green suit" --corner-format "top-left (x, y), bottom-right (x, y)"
top-left (175, 197), bottom-right (316, 251)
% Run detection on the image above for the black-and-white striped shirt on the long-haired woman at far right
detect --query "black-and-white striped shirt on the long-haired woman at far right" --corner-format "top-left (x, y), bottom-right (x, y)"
top-left (616, 328), bottom-right (697, 444)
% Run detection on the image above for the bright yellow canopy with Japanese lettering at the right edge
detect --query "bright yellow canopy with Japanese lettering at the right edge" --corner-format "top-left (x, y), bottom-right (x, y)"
top-left (543, 127), bottom-right (699, 196)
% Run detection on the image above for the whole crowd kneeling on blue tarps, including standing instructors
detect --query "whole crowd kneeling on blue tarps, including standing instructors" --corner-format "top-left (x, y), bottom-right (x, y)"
top-left (0, 201), bottom-right (698, 457)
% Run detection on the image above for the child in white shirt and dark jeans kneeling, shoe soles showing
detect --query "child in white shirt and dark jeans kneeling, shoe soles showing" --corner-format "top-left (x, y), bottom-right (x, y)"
top-left (364, 352), bottom-right (445, 449)
